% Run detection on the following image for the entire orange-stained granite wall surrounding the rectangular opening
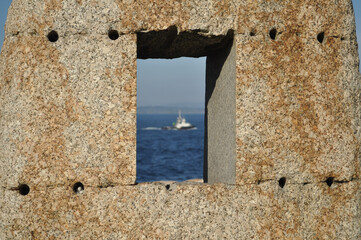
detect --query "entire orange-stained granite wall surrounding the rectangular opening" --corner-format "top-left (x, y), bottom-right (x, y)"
top-left (0, 0), bottom-right (361, 239)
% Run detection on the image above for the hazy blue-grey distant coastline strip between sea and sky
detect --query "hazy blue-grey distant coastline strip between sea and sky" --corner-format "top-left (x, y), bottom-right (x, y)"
top-left (137, 106), bottom-right (204, 114)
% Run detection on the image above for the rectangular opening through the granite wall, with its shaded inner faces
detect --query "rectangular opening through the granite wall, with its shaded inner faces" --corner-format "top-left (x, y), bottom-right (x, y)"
top-left (137, 26), bottom-right (236, 184)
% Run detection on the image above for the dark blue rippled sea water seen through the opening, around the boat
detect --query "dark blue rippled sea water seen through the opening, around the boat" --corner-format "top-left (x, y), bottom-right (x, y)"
top-left (137, 114), bottom-right (204, 183)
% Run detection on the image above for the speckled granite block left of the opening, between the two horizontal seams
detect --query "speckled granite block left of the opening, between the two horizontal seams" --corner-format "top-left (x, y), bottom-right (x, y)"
top-left (0, 31), bottom-right (136, 187)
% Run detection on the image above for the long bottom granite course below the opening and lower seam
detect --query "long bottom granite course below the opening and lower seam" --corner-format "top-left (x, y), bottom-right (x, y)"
top-left (0, 181), bottom-right (361, 239)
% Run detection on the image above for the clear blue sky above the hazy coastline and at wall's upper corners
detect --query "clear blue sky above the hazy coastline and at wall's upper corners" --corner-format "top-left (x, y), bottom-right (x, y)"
top-left (0, 0), bottom-right (361, 107)
